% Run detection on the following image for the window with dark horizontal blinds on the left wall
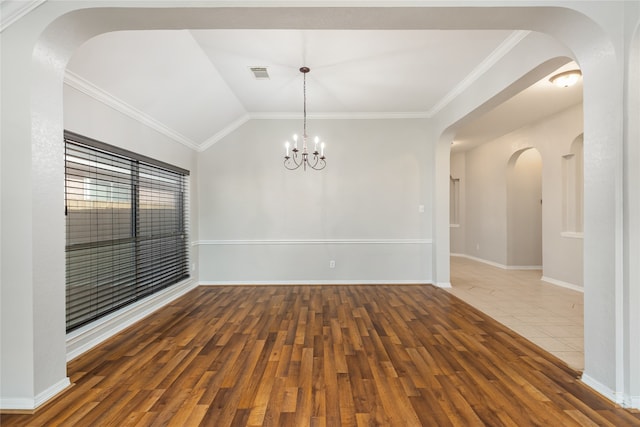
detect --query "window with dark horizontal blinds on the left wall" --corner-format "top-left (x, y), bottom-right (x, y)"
top-left (65, 131), bottom-right (189, 332)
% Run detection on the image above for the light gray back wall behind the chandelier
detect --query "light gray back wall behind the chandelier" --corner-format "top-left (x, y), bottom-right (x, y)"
top-left (198, 119), bottom-right (433, 283)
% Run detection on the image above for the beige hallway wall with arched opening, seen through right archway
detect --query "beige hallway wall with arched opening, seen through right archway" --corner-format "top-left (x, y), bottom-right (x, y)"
top-left (451, 105), bottom-right (583, 287)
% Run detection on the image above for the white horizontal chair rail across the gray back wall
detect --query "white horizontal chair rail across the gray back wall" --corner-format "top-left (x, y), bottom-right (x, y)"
top-left (192, 239), bottom-right (433, 246)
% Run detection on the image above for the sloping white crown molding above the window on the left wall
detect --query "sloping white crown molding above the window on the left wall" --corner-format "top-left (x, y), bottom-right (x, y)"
top-left (64, 70), bottom-right (199, 150)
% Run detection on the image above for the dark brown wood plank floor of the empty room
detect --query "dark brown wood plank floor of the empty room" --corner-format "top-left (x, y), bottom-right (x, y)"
top-left (0, 285), bottom-right (640, 427)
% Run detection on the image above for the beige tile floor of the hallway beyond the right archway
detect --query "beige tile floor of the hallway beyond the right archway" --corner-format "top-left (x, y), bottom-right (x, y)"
top-left (447, 256), bottom-right (584, 371)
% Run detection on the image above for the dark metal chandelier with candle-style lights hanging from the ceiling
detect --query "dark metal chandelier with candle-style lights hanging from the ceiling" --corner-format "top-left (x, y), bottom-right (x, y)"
top-left (284, 67), bottom-right (327, 170)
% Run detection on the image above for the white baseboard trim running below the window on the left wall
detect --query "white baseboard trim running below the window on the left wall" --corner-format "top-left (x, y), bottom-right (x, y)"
top-left (67, 280), bottom-right (198, 361)
